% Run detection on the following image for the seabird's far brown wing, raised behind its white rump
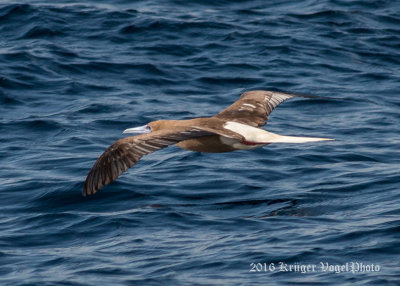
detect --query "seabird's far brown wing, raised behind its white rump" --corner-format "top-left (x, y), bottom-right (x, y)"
top-left (214, 90), bottom-right (296, 127)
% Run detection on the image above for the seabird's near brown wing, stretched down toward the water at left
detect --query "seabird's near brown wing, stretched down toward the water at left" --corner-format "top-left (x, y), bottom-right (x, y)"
top-left (82, 122), bottom-right (242, 196)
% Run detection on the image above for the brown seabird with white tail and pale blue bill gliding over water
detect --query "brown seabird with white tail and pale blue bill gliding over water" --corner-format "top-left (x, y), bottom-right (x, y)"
top-left (83, 90), bottom-right (333, 196)
